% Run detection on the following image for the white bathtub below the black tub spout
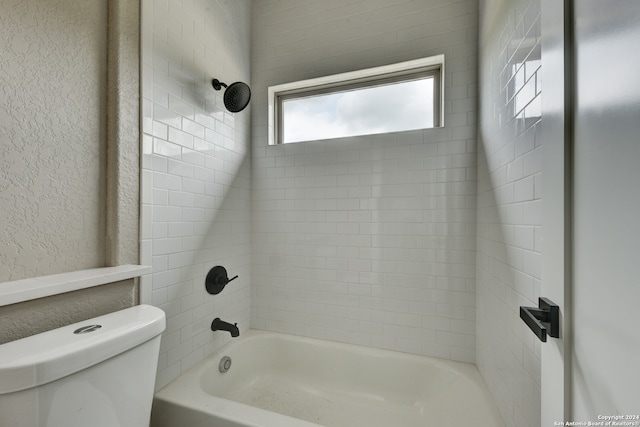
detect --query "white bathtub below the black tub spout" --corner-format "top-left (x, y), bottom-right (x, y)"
top-left (151, 330), bottom-right (504, 427)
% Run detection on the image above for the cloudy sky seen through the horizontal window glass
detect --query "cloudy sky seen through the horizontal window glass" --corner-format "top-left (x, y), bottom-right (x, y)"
top-left (282, 77), bottom-right (434, 143)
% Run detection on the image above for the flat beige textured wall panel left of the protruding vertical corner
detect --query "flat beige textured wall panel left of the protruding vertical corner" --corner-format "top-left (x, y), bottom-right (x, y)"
top-left (0, 0), bottom-right (107, 281)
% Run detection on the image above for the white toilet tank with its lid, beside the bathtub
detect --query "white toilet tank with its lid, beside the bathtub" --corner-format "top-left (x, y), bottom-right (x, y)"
top-left (0, 305), bottom-right (165, 427)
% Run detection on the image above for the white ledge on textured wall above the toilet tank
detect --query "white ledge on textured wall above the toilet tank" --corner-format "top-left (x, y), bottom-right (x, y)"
top-left (0, 264), bottom-right (151, 306)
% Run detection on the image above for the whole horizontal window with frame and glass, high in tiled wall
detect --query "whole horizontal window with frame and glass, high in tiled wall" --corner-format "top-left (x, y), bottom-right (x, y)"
top-left (269, 55), bottom-right (444, 144)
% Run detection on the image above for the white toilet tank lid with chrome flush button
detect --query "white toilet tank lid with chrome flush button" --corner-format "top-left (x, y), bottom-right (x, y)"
top-left (0, 305), bottom-right (166, 394)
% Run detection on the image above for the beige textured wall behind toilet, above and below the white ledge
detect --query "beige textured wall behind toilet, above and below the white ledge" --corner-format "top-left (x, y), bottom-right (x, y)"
top-left (0, 0), bottom-right (140, 342)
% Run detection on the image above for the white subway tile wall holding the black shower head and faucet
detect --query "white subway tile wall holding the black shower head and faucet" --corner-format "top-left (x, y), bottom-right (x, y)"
top-left (141, 0), bottom-right (251, 388)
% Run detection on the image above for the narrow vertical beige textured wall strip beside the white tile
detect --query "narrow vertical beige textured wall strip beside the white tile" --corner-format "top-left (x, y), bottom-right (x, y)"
top-left (105, 0), bottom-right (140, 266)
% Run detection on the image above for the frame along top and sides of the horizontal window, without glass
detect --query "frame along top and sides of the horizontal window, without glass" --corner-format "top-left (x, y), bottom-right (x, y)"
top-left (268, 55), bottom-right (444, 145)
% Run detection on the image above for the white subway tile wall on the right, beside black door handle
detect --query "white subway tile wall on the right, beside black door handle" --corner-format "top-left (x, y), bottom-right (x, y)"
top-left (476, 0), bottom-right (542, 427)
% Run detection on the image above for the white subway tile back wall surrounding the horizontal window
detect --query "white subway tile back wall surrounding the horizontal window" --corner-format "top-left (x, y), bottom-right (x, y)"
top-left (251, 0), bottom-right (478, 362)
